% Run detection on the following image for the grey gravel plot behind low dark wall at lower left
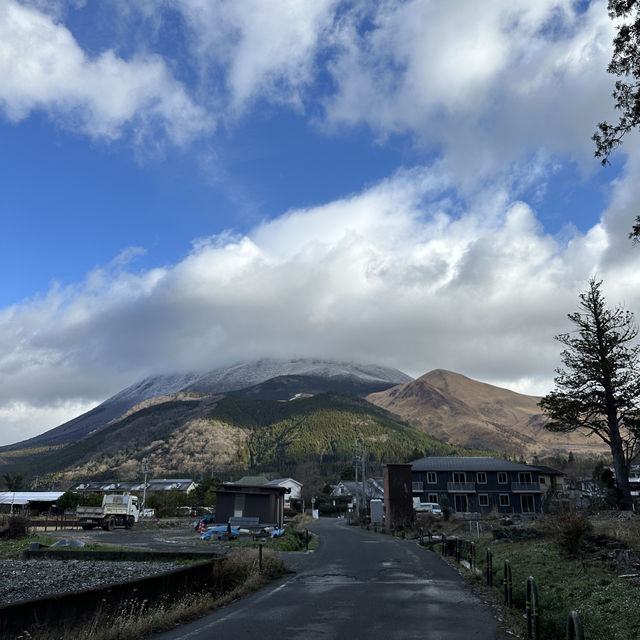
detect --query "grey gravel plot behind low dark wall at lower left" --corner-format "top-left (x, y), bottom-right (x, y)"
top-left (0, 558), bottom-right (176, 605)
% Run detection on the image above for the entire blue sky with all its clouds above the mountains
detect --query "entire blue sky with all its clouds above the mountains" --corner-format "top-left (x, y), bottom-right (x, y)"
top-left (0, 0), bottom-right (640, 444)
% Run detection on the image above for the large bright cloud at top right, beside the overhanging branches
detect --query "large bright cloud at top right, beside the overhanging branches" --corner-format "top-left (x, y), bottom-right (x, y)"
top-left (325, 0), bottom-right (613, 183)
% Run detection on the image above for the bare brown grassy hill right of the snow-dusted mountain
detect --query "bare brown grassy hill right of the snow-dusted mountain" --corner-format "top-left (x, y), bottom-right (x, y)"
top-left (367, 369), bottom-right (606, 455)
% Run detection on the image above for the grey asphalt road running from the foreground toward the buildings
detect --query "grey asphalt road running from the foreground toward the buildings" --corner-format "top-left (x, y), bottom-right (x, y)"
top-left (149, 519), bottom-right (506, 640)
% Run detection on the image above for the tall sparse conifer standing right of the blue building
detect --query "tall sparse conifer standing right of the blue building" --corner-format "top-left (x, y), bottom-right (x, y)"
top-left (540, 279), bottom-right (640, 509)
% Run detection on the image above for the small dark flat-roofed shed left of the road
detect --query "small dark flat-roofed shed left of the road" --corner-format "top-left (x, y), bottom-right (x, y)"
top-left (216, 482), bottom-right (290, 528)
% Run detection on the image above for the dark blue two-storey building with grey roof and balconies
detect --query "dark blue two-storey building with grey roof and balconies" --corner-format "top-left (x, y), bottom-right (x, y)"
top-left (410, 457), bottom-right (546, 515)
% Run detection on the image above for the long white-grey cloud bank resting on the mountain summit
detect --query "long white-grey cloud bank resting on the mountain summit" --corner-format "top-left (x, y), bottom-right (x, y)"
top-left (0, 167), bottom-right (640, 442)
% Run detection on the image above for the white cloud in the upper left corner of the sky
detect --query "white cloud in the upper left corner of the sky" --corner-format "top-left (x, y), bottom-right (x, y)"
top-left (0, 0), bottom-right (213, 145)
